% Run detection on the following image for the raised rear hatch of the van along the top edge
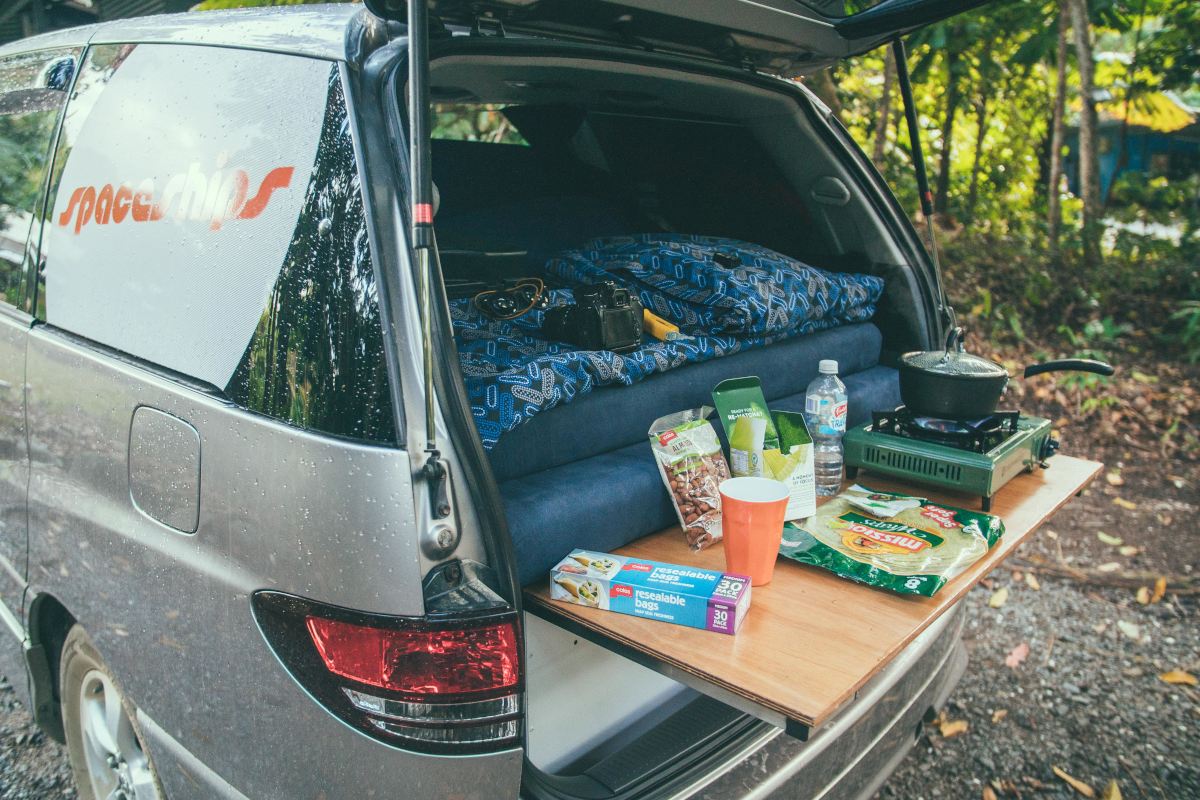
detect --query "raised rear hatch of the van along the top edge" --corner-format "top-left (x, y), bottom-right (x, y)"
top-left (376, 0), bottom-right (989, 77)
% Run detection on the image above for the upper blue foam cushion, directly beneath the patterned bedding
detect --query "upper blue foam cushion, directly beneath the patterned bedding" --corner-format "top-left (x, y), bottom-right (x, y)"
top-left (488, 323), bottom-right (895, 481)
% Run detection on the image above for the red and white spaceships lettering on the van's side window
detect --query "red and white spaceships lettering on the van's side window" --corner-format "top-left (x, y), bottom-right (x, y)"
top-left (58, 162), bottom-right (295, 234)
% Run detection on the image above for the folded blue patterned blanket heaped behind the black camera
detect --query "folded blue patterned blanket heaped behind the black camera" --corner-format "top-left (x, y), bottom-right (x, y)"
top-left (546, 234), bottom-right (883, 336)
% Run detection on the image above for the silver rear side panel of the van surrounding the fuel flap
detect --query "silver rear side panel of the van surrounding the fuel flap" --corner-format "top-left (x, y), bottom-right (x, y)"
top-left (22, 327), bottom-right (501, 800)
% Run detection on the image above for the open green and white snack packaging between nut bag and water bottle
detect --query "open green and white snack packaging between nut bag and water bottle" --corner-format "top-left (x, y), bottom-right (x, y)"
top-left (713, 377), bottom-right (817, 519)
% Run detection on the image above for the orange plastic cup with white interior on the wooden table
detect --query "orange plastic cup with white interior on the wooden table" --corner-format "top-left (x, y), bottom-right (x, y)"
top-left (720, 477), bottom-right (787, 587)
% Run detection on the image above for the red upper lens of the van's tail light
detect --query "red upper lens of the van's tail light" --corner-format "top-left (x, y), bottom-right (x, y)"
top-left (306, 616), bottom-right (521, 700)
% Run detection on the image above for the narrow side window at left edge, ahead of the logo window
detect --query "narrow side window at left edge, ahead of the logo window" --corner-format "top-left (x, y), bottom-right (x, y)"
top-left (0, 50), bottom-right (78, 306)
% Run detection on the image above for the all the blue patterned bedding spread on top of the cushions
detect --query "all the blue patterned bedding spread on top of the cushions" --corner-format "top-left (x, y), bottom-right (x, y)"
top-left (450, 234), bottom-right (883, 450)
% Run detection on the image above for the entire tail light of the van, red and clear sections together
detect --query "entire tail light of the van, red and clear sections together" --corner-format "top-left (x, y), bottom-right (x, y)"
top-left (253, 591), bottom-right (523, 753)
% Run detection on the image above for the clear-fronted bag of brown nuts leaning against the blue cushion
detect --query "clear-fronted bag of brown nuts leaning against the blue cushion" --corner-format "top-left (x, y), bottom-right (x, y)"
top-left (649, 405), bottom-right (730, 551)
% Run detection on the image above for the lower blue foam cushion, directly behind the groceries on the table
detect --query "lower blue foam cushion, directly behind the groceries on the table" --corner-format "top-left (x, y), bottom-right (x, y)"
top-left (493, 367), bottom-right (900, 584)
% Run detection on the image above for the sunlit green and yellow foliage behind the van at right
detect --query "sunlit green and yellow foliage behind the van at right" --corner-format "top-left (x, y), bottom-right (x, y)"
top-left (835, 0), bottom-right (1200, 367)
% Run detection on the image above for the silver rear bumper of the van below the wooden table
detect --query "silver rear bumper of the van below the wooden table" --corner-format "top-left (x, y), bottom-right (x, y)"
top-left (696, 604), bottom-right (967, 800)
